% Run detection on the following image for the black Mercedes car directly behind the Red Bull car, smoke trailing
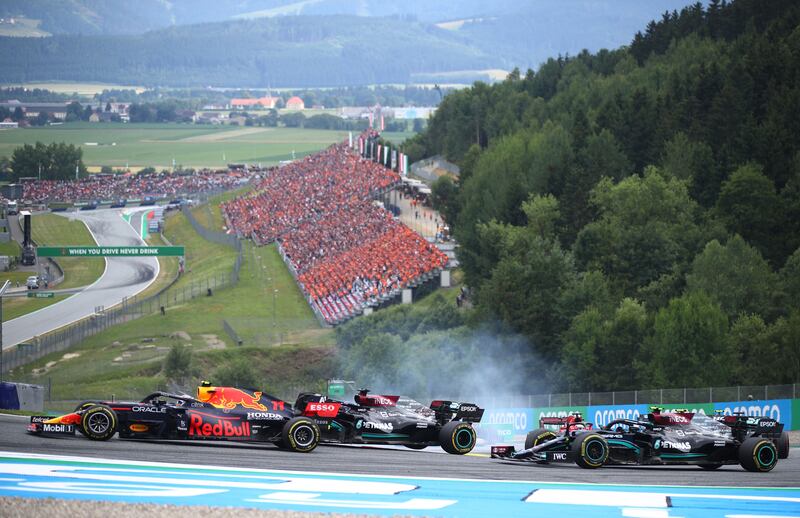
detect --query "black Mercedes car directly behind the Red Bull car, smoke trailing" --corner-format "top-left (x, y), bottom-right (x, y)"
top-left (295, 389), bottom-right (483, 455)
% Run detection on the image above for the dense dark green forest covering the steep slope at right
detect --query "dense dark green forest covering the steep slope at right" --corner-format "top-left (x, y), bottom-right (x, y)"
top-left (340, 0), bottom-right (800, 390)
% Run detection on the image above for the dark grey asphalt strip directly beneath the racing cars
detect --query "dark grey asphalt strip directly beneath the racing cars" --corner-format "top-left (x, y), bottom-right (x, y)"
top-left (0, 414), bottom-right (800, 487)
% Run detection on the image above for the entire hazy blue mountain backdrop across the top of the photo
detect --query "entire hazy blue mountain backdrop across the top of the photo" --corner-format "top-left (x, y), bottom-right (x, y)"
top-left (0, 0), bottom-right (708, 87)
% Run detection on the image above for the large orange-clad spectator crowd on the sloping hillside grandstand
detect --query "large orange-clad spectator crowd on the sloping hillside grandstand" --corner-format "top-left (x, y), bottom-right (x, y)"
top-left (223, 140), bottom-right (447, 324)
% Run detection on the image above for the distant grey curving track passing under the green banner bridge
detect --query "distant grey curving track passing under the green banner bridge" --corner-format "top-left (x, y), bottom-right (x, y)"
top-left (3, 209), bottom-right (159, 348)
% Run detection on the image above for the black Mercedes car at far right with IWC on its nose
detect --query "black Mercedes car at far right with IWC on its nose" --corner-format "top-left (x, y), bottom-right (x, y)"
top-left (491, 407), bottom-right (789, 472)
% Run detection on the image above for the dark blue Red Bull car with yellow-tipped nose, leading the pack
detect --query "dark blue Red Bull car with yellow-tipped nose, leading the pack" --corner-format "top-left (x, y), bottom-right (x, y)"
top-left (28, 382), bottom-right (320, 452)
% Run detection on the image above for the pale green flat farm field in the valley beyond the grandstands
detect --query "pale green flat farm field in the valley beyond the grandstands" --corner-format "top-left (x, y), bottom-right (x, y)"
top-left (0, 122), bottom-right (407, 170)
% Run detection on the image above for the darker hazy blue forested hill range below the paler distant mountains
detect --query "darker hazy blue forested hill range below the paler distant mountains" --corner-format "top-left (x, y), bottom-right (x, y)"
top-left (0, 16), bottom-right (498, 87)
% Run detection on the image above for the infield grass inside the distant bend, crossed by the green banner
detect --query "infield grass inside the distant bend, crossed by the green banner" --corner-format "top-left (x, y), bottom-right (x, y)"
top-left (31, 214), bottom-right (105, 289)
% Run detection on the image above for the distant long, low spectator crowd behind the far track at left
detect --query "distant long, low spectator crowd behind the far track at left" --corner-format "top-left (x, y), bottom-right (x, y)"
top-left (22, 169), bottom-right (254, 203)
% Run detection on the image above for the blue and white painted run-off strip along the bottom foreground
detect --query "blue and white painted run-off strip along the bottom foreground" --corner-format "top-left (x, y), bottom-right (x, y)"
top-left (0, 452), bottom-right (800, 518)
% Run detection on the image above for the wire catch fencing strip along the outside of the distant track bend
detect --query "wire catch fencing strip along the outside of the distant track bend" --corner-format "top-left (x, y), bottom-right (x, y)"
top-left (0, 207), bottom-right (243, 375)
